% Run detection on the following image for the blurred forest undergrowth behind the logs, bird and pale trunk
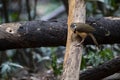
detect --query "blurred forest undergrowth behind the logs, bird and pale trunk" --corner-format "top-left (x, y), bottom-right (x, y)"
top-left (0, 0), bottom-right (120, 80)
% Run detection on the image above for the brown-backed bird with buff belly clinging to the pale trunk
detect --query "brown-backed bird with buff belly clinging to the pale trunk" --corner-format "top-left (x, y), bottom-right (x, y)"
top-left (70, 23), bottom-right (98, 47)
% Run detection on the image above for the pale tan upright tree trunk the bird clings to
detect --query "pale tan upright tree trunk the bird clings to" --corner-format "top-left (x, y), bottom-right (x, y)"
top-left (61, 0), bottom-right (86, 80)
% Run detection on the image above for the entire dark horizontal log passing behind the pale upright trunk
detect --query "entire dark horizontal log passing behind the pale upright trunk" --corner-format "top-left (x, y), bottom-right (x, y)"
top-left (0, 17), bottom-right (120, 50)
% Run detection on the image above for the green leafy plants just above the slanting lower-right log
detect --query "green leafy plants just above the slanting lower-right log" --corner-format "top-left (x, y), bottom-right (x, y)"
top-left (81, 48), bottom-right (114, 69)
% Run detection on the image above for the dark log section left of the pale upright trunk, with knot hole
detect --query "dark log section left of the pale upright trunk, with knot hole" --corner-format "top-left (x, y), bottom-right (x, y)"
top-left (0, 21), bottom-right (67, 50)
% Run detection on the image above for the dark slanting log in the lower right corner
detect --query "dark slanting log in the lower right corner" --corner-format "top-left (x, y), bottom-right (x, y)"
top-left (79, 57), bottom-right (120, 80)
